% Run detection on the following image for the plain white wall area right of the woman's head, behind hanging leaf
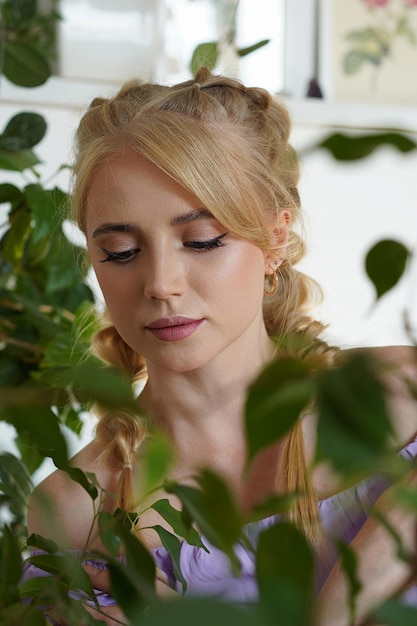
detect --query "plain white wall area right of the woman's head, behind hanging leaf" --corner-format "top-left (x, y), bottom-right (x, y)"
top-left (294, 122), bottom-right (417, 346)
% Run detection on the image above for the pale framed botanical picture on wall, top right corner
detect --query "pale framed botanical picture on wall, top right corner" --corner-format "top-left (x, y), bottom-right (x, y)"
top-left (320, 0), bottom-right (417, 106)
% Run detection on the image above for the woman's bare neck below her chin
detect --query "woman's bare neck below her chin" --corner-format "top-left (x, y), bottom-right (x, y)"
top-left (137, 339), bottom-right (274, 500)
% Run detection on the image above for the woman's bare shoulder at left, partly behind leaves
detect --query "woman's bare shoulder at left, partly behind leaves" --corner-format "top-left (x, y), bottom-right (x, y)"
top-left (28, 441), bottom-right (118, 549)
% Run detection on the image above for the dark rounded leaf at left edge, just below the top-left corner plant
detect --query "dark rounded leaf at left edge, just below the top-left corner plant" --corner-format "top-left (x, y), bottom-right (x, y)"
top-left (0, 113), bottom-right (46, 152)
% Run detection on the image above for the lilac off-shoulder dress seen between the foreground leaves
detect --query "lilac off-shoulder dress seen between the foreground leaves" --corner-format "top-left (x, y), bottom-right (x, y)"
top-left (24, 439), bottom-right (417, 606)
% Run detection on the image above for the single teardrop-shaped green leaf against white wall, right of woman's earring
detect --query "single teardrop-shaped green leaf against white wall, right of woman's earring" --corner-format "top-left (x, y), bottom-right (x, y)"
top-left (365, 239), bottom-right (411, 299)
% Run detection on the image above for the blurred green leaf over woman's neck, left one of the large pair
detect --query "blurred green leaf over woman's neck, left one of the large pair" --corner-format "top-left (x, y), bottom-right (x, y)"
top-left (245, 358), bottom-right (313, 461)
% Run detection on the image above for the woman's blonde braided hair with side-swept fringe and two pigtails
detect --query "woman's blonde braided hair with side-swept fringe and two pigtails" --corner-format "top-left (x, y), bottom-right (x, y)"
top-left (73, 68), bottom-right (336, 543)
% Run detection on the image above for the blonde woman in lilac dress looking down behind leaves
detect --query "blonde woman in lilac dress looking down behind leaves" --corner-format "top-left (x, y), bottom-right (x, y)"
top-left (27, 69), bottom-right (417, 624)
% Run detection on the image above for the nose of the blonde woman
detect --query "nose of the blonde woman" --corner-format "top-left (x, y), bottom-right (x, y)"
top-left (144, 252), bottom-right (185, 300)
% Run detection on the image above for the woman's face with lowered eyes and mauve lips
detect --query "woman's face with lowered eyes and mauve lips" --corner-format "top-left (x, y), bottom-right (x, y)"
top-left (86, 152), bottom-right (271, 372)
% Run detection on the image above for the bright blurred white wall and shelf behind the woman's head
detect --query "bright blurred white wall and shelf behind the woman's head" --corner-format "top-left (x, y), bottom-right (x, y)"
top-left (0, 0), bottom-right (417, 346)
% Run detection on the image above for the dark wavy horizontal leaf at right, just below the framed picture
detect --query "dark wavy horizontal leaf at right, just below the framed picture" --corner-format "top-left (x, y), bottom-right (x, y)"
top-left (318, 131), bottom-right (417, 161)
